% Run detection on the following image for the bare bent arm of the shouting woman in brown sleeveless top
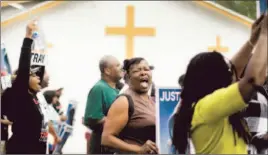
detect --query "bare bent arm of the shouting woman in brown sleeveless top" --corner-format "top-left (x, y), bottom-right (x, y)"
top-left (101, 96), bottom-right (158, 154)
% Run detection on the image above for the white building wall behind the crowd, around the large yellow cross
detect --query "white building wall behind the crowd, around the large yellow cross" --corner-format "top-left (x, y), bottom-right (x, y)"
top-left (1, 1), bottom-right (249, 153)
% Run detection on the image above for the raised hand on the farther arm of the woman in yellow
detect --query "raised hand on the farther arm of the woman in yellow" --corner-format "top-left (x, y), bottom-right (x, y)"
top-left (249, 14), bottom-right (265, 46)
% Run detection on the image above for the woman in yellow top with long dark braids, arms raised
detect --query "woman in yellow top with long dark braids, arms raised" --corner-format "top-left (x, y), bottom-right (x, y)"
top-left (173, 15), bottom-right (267, 154)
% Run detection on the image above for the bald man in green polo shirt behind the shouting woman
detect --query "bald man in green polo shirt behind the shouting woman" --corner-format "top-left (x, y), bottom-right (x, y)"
top-left (84, 56), bottom-right (123, 154)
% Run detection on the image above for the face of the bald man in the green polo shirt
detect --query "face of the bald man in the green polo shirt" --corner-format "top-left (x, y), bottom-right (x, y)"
top-left (106, 58), bottom-right (123, 82)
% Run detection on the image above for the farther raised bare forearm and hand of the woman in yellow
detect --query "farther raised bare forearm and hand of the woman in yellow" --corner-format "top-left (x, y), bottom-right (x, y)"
top-left (231, 14), bottom-right (264, 78)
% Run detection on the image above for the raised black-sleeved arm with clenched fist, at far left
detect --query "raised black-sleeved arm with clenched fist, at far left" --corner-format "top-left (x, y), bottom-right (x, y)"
top-left (13, 21), bottom-right (37, 92)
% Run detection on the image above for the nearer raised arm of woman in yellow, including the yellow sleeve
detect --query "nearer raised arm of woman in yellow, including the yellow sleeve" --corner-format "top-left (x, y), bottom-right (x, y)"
top-left (194, 16), bottom-right (267, 123)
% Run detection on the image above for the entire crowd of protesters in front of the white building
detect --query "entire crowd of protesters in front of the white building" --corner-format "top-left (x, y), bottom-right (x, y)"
top-left (1, 14), bottom-right (268, 154)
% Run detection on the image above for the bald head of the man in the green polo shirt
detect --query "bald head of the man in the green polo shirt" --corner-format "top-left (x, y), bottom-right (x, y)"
top-left (99, 55), bottom-right (122, 82)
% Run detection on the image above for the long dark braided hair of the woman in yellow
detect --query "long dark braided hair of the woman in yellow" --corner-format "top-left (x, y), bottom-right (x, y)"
top-left (172, 51), bottom-right (249, 154)
